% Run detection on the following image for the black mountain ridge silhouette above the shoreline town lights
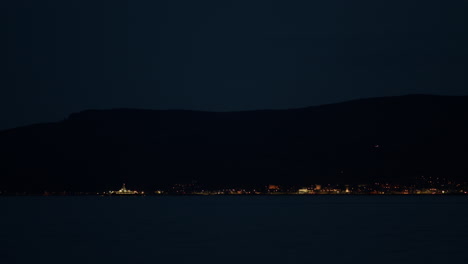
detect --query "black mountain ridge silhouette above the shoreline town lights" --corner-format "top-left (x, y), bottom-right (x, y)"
top-left (0, 95), bottom-right (468, 192)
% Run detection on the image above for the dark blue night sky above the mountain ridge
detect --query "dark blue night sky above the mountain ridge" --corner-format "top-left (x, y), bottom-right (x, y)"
top-left (0, 0), bottom-right (468, 129)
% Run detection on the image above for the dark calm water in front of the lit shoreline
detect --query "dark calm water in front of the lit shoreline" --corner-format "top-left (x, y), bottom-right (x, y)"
top-left (0, 196), bottom-right (468, 264)
